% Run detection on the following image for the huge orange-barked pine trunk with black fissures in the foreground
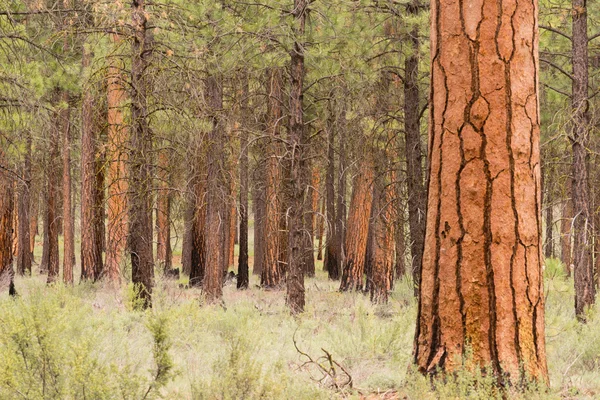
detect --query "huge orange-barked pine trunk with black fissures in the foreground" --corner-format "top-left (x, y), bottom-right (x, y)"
top-left (414, 0), bottom-right (548, 385)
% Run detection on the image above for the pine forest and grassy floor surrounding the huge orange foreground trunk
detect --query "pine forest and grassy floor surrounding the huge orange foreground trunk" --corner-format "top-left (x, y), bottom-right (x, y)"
top-left (0, 0), bottom-right (600, 398)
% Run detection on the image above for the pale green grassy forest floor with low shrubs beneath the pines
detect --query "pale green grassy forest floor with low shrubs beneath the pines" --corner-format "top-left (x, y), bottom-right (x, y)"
top-left (0, 236), bottom-right (600, 399)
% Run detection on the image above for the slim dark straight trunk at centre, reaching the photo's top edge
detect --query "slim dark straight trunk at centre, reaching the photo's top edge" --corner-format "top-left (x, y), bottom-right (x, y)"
top-left (286, 0), bottom-right (308, 314)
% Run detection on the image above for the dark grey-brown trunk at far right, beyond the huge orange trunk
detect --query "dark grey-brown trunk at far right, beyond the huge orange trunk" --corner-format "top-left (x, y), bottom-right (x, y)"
top-left (571, 0), bottom-right (596, 320)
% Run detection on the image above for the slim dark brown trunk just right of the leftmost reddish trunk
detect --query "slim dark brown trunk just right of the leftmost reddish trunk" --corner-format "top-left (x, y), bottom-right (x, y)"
top-left (17, 133), bottom-right (32, 276)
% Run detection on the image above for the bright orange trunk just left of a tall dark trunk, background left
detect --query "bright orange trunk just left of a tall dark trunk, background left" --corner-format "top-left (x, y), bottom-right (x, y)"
top-left (106, 35), bottom-right (129, 285)
